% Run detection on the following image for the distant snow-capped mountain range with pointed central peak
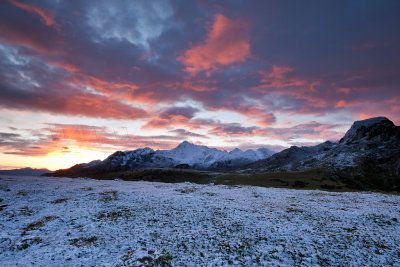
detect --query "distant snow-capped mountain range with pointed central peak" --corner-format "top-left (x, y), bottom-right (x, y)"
top-left (48, 141), bottom-right (275, 176)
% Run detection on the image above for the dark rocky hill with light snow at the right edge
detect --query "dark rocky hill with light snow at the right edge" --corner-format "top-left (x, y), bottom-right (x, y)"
top-left (240, 117), bottom-right (400, 190)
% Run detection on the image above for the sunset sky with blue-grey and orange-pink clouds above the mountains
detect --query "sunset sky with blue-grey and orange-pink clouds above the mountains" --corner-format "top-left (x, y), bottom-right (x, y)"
top-left (0, 0), bottom-right (400, 170)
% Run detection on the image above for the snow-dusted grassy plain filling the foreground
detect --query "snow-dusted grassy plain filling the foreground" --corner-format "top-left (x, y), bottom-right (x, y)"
top-left (0, 176), bottom-right (400, 266)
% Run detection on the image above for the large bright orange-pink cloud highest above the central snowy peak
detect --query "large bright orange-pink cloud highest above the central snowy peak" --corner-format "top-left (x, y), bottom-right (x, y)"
top-left (178, 14), bottom-right (251, 74)
